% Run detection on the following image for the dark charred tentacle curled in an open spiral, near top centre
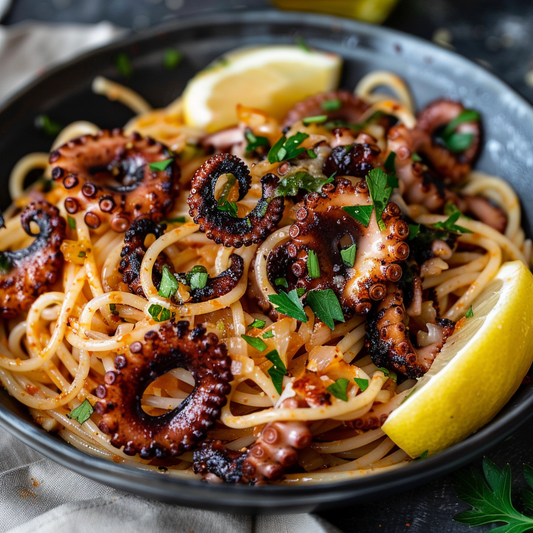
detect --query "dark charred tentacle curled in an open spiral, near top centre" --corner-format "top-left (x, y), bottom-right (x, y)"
top-left (187, 153), bottom-right (284, 248)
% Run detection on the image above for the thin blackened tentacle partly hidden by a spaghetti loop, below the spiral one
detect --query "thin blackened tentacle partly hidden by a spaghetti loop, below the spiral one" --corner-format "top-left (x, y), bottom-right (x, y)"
top-left (119, 217), bottom-right (244, 303)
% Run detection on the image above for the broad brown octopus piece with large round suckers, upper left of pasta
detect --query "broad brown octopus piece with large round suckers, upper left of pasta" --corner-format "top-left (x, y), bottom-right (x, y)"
top-left (50, 129), bottom-right (180, 232)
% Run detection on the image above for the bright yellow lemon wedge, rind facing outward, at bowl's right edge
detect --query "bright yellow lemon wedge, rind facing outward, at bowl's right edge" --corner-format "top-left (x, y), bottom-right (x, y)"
top-left (383, 261), bottom-right (533, 458)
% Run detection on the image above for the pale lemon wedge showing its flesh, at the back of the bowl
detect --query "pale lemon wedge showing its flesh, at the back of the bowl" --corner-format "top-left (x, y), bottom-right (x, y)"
top-left (183, 45), bottom-right (342, 132)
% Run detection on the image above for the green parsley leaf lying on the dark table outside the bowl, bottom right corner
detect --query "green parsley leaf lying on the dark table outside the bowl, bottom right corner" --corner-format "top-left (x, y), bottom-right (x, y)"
top-left (453, 457), bottom-right (533, 533)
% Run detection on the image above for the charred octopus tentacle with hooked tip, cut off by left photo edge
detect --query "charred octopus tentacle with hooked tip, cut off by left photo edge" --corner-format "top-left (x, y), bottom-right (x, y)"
top-left (0, 202), bottom-right (65, 318)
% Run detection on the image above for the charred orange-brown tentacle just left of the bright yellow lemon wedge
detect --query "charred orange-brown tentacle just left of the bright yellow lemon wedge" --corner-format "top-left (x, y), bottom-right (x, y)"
top-left (367, 284), bottom-right (455, 378)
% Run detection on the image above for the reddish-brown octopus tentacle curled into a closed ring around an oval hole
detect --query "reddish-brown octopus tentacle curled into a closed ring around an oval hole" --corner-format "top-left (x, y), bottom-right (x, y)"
top-left (95, 320), bottom-right (233, 459)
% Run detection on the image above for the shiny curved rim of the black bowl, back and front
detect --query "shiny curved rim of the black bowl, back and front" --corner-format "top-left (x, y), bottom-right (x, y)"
top-left (0, 9), bottom-right (533, 513)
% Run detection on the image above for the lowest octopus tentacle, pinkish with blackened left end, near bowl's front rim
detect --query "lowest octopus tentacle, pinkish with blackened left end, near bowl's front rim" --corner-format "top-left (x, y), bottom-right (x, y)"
top-left (193, 398), bottom-right (312, 485)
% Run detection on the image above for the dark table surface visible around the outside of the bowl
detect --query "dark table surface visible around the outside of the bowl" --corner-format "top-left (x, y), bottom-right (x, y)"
top-left (3, 0), bottom-right (533, 533)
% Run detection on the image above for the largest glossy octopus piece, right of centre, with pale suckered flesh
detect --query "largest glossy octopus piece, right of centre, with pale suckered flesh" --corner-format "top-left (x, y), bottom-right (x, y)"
top-left (267, 178), bottom-right (409, 315)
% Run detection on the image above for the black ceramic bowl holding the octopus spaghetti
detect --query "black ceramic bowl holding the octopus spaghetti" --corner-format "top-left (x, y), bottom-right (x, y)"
top-left (0, 11), bottom-right (533, 513)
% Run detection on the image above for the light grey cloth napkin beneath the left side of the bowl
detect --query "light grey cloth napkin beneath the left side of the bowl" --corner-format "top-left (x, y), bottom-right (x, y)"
top-left (0, 22), bottom-right (340, 533)
